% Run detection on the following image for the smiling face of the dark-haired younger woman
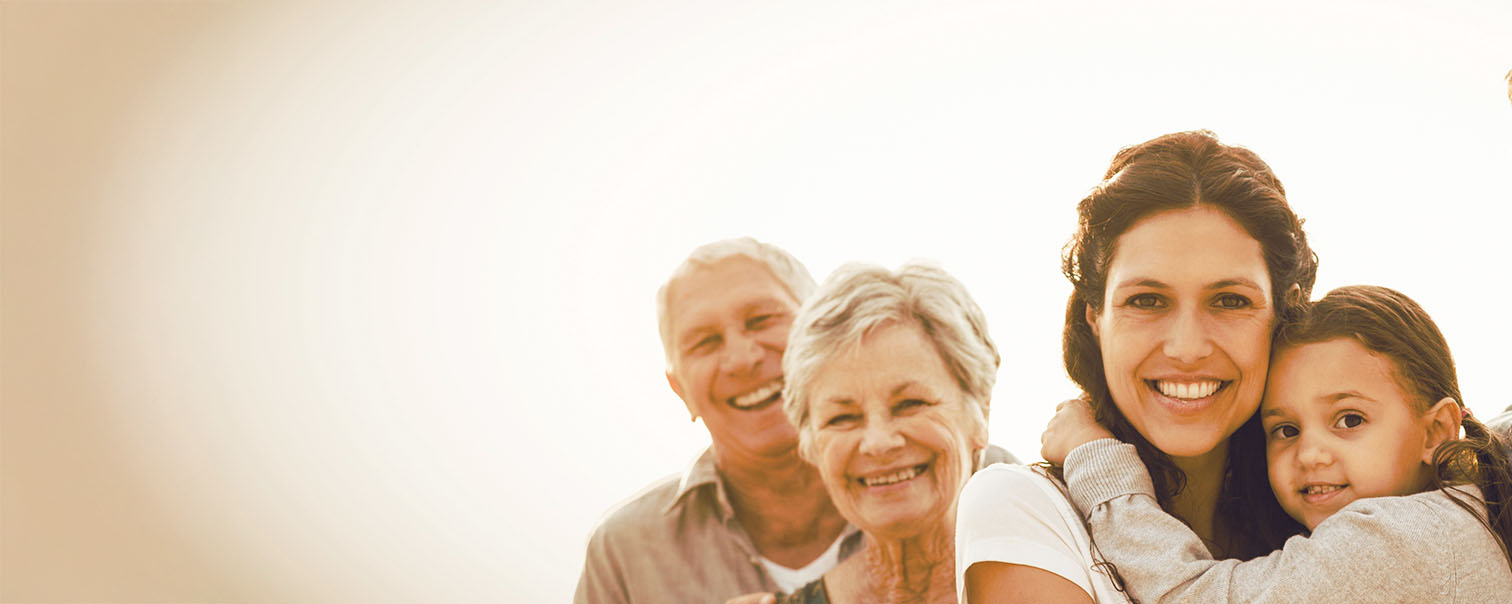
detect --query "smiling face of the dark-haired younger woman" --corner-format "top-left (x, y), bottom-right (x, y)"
top-left (1087, 206), bottom-right (1275, 457)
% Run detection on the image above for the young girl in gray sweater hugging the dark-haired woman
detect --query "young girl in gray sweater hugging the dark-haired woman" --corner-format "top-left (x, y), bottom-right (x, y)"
top-left (1043, 286), bottom-right (1512, 604)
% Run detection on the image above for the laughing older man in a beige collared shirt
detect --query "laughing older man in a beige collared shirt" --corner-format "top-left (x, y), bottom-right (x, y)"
top-left (575, 238), bottom-right (860, 604)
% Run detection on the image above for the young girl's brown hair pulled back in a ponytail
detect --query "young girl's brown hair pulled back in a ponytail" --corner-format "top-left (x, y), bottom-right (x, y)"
top-left (1273, 285), bottom-right (1512, 568)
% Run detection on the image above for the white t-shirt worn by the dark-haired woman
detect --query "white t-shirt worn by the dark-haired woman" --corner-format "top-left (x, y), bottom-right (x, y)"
top-left (956, 463), bottom-right (1128, 604)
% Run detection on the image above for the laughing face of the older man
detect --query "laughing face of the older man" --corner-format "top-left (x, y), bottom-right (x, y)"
top-left (667, 256), bottom-right (798, 463)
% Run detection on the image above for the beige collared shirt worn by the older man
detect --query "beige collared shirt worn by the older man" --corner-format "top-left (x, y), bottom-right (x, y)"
top-left (573, 447), bottom-right (1013, 604)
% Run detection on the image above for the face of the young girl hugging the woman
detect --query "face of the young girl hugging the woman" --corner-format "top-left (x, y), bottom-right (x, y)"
top-left (1259, 338), bottom-right (1436, 530)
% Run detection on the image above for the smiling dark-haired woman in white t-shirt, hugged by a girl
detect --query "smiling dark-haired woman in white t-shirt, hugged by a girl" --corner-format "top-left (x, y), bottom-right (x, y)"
top-left (956, 132), bottom-right (1317, 602)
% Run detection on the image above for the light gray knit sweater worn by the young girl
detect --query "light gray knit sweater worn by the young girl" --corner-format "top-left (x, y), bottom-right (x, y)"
top-left (1066, 439), bottom-right (1512, 604)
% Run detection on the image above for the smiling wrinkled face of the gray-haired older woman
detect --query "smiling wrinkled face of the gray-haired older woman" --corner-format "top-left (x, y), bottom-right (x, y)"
top-left (804, 322), bottom-right (986, 537)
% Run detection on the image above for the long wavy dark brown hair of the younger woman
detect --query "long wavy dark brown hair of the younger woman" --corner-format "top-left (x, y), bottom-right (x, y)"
top-left (1061, 130), bottom-right (1317, 557)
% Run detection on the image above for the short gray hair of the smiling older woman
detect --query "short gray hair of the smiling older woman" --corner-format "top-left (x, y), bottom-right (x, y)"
top-left (782, 262), bottom-right (1001, 453)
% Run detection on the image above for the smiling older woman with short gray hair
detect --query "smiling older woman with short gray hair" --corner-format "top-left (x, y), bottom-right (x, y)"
top-left (783, 265), bottom-right (1007, 602)
